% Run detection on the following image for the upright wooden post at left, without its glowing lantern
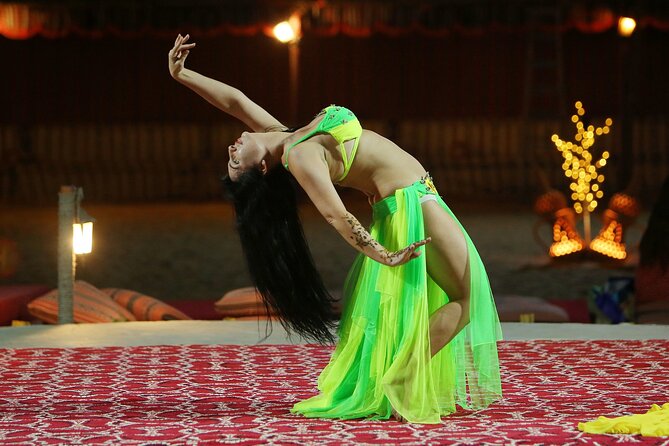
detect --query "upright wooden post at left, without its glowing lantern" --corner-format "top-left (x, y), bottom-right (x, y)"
top-left (58, 186), bottom-right (77, 324)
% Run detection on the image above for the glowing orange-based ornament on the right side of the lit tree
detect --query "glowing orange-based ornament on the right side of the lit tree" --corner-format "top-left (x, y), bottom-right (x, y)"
top-left (590, 193), bottom-right (640, 260)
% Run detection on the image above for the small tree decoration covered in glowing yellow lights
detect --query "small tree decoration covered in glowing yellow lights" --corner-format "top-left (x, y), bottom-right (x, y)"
top-left (551, 101), bottom-right (613, 244)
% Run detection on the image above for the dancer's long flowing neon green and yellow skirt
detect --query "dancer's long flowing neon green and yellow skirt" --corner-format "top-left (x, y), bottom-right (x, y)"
top-left (292, 176), bottom-right (502, 423)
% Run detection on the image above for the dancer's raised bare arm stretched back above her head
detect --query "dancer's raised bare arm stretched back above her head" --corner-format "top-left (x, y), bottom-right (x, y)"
top-left (168, 34), bottom-right (285, 132)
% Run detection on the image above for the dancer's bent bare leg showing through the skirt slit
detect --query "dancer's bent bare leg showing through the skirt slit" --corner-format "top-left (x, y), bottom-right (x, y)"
top-left (422, 200), bottom-right (470, 356)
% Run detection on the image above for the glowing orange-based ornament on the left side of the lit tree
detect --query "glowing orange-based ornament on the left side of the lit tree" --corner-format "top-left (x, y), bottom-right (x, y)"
top-left (534, 189), bottom-right (585, 257)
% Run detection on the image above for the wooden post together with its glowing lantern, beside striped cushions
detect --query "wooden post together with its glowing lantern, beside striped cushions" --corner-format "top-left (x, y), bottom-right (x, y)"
top-left (58, 186), bottom-right (95, 324)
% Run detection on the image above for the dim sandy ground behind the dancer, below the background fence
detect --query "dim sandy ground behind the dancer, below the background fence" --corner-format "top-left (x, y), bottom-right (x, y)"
top-left (0, 195), bottom-right (647, 306)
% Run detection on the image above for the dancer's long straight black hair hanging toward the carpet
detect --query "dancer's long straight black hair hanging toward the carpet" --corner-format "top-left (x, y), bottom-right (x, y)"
top-left (223, 166), bottom-right (335, 343)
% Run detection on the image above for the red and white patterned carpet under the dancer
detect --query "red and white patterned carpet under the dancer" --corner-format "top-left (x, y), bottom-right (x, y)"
top-left (0, 340), bottom-right (669, 445)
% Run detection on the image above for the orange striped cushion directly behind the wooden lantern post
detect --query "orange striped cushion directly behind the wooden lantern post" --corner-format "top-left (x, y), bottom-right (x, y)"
top-left (28, 280), bottom-right (136, 324)
